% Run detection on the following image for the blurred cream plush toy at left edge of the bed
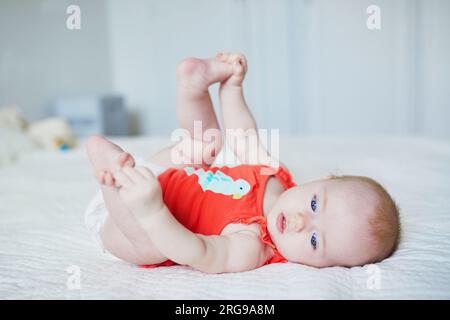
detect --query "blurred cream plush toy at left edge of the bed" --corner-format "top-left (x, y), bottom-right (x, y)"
top-left (0, 107), bottom-right (76, 152)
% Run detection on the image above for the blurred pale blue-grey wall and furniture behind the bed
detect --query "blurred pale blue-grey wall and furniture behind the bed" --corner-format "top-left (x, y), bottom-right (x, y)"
top-left (0, 0), bottom-right (450, 140)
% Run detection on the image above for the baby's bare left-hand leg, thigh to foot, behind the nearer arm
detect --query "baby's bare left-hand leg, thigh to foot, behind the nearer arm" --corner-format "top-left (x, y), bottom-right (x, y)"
top-left (87, 136), bottom-right (166, 264)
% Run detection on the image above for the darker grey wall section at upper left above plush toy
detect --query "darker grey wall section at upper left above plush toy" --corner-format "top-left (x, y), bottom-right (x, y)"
top-left (0, 0), bottom-right (112, 120)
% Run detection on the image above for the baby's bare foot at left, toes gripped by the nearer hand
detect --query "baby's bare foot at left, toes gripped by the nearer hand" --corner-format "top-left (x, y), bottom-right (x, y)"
top-left (86, 136), bottom-right (135, 186)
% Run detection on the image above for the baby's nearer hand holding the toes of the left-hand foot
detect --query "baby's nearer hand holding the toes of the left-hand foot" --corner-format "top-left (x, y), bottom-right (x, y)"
top-left (114, 167), bottom-right (164, 220)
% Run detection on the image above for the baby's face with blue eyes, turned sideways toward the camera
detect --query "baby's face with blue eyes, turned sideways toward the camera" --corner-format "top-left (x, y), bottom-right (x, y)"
top-left (267, 179), bottom-right (376, 267)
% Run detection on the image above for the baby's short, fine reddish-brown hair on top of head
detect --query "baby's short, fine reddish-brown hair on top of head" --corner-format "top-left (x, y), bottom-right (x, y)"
top-left (329, 175), bottom-right (400, 263)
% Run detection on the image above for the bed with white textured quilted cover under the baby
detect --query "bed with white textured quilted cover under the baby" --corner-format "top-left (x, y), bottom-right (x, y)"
top-left (0, 136), bottom-right (450, 299)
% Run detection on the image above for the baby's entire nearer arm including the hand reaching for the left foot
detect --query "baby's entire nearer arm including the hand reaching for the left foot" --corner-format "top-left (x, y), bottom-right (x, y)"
top-left (114, 167), bottom-right (267, 273)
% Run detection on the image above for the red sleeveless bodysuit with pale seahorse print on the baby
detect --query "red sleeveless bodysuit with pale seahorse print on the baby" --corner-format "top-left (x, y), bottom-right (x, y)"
top-left (142, 165), bottom-right (295, 268)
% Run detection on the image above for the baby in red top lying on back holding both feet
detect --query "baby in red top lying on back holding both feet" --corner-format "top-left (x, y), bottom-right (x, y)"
top-left (87, 53), bottom-right (399, 273)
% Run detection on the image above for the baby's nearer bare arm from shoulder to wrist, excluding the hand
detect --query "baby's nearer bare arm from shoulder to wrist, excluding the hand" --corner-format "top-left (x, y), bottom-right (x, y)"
top-left (142, 207), bottom-right (265, 273)
